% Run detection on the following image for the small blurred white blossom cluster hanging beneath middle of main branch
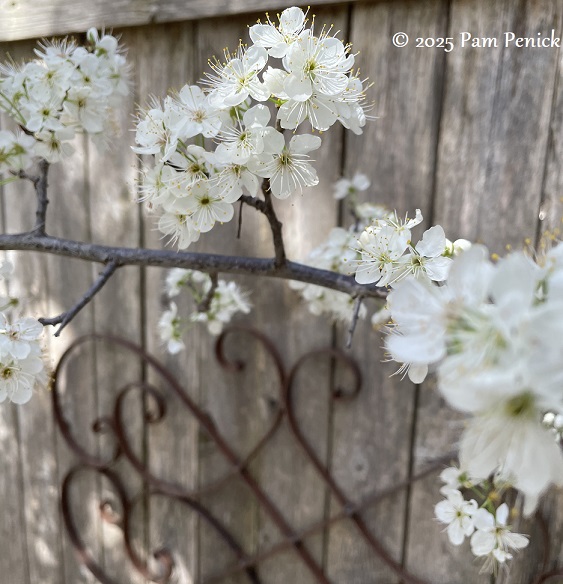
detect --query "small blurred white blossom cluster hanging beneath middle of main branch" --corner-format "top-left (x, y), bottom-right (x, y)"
top-left (158, 268), bottom-right (250, 354)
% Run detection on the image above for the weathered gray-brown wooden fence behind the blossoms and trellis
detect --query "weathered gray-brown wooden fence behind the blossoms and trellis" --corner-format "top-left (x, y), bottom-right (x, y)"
top-left (0, 0), bottom-right (563, 584)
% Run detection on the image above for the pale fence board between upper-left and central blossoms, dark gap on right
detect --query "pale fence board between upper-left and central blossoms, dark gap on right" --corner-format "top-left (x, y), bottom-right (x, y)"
top-left (87, 30), bottom-right (146, 584)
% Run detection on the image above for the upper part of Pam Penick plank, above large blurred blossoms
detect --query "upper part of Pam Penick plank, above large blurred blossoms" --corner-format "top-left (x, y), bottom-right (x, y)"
top-left (436, 1), bottom-right (561, 252)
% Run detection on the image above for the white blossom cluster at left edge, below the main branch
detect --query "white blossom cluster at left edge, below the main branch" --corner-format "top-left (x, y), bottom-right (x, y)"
top-left (0, 262), bottom-right (46, 404)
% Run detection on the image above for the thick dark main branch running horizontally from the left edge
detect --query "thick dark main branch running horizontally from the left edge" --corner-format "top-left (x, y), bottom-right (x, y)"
top-left (0, 229), bottom-right (387, 298)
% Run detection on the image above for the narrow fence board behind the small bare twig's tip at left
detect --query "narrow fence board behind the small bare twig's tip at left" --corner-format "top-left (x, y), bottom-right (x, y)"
top-left (47, 136), bottom-right (103, 583)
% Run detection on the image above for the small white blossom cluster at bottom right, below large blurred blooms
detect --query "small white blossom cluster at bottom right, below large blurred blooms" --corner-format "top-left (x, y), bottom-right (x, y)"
top-left (434, 467), bottom-right (528, 573)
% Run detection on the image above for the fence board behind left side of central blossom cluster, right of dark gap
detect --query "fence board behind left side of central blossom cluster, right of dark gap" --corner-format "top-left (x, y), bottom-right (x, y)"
top-left (134, 23), bottom-right (200, 582)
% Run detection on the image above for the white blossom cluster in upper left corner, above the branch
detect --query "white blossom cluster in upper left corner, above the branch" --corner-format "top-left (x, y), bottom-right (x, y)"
top-left (0, 29), bottom-right (129, 167)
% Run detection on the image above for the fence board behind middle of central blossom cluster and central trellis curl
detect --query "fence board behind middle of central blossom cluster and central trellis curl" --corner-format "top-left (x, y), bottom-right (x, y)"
top-left (192, 17), bottom-right (264, 584)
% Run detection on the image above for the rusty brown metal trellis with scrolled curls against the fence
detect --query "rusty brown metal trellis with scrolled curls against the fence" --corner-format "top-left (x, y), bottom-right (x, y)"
top-left (52, 327), bottom-right (559, 584)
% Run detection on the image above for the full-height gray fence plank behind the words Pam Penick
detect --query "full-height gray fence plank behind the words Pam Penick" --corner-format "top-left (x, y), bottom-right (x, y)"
top-left (407, 1), bottom-right (562, 584)
